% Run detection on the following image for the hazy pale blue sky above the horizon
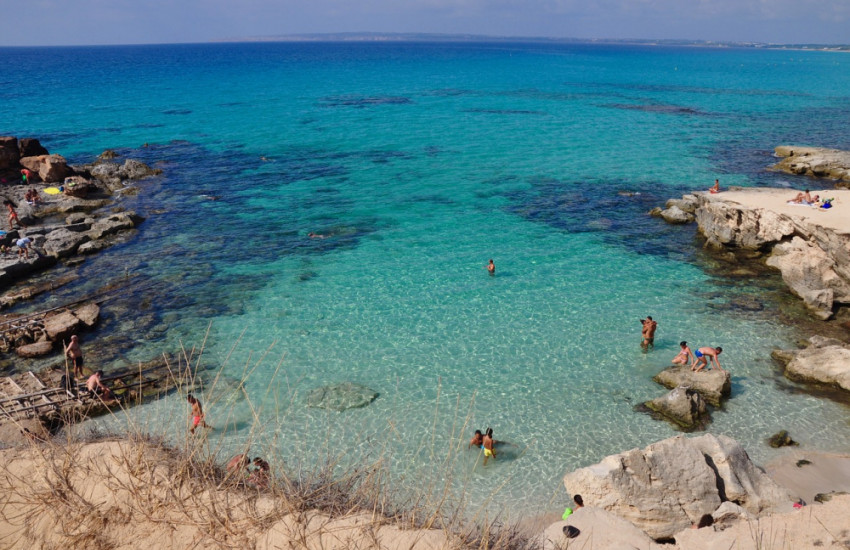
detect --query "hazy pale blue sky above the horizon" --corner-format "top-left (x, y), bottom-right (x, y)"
top-left (0, 0), bottom-right (850, 46)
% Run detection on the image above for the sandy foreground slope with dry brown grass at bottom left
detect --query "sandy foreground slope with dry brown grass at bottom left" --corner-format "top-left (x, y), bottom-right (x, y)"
top-left (0, 336), bottom-right (534, 550)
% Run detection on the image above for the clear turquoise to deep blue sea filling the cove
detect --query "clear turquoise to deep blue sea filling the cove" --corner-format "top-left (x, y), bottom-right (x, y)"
top-left (0, 43), bottom-right (850, 514)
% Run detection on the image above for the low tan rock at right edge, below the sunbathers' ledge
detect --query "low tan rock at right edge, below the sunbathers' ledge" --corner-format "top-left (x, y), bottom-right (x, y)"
top-left (771, 336), bottom-right (850, 392)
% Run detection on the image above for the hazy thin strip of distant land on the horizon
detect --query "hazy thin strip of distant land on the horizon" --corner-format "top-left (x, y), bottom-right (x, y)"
top-left (215, 32), bottom-right (850, 51)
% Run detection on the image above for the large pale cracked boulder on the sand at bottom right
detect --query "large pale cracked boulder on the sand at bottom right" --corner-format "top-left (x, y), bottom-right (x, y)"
top-left (564, 434), bottom-right (791, 548)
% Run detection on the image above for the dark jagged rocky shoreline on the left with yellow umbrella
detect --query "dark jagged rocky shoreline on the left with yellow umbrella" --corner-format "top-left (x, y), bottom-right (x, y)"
top-left (0, 136), bottom-right (166, 430)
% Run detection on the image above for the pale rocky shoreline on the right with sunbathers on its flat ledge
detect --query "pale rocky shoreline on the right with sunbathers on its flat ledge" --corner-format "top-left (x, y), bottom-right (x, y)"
top-left (650, 146), bottom-right (850, 406)
